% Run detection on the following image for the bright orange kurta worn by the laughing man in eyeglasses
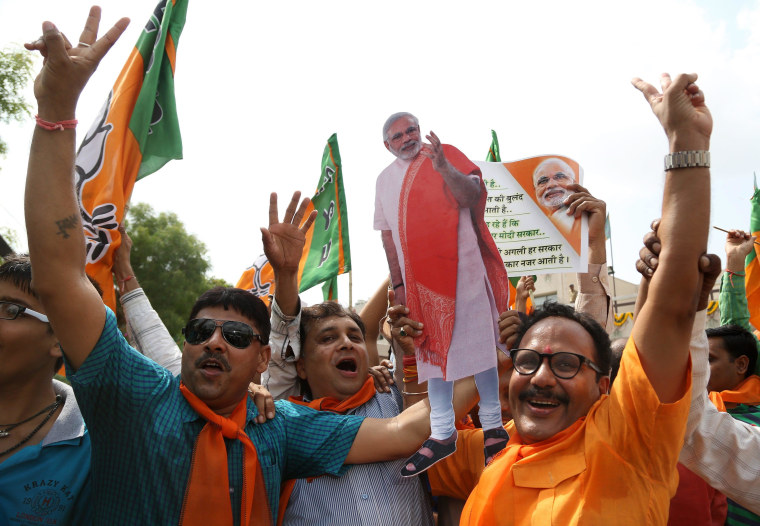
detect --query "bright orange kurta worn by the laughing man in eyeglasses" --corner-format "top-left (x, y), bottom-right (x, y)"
top-left (431, 340), bottom-right (691, 526)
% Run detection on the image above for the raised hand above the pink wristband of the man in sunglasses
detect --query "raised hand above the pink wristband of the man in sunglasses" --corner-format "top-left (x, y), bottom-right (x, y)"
top-left (24, 6), bottom-right (129, 113)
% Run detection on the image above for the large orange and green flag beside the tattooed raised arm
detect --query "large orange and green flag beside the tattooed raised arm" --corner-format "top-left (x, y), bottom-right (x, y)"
top-left (76, 0), bottom-right (187, 310)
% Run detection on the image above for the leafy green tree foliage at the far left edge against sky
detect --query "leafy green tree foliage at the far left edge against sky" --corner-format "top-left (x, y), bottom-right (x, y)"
top-left (0, 49), bottom-right (32, 155)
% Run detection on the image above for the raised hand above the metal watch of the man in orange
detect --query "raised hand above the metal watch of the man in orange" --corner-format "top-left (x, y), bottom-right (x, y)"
top-left (631, 73), bottom-right (713, 151)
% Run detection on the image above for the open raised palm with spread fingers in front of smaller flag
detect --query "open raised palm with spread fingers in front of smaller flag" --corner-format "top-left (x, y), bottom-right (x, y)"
top-left (261, 192), bottom-right (317, 272)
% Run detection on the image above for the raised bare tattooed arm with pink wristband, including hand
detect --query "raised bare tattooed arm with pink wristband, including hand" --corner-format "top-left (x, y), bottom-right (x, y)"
top-left (24, 7), bottom-right (129, 369)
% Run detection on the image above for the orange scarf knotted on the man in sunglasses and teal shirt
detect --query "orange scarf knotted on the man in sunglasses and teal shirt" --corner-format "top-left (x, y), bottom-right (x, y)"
top-left (179, 382), bottom-right (272, 526)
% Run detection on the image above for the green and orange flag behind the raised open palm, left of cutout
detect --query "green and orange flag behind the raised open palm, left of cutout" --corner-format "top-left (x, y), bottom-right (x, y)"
top-left (237, 134), bottom-right (351, 304)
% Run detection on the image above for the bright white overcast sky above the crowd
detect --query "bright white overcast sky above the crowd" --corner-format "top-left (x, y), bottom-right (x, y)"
top-left (0, 0), bottom-right (760, 303)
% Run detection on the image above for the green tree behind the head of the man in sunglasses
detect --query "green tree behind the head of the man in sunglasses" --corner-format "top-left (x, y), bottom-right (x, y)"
top-left (125, 203), bottom-right (227, 341)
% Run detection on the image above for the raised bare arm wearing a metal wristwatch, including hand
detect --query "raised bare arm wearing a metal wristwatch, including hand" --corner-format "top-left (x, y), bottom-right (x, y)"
top-left (631, 74), bottom-right (712, 403)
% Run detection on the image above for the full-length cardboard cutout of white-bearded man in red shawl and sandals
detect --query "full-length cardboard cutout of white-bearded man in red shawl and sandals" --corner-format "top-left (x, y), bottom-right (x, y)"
top-left (374, 112), bottom-right (509, 476)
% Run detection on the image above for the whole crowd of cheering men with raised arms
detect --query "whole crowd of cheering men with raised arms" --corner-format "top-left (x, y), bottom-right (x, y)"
top-left (0, 8), bottom-right (760, 526)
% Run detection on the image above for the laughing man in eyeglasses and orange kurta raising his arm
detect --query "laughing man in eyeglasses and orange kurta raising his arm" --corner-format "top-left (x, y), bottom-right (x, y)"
top-left (431, 75), bottom-right (712, 525)
